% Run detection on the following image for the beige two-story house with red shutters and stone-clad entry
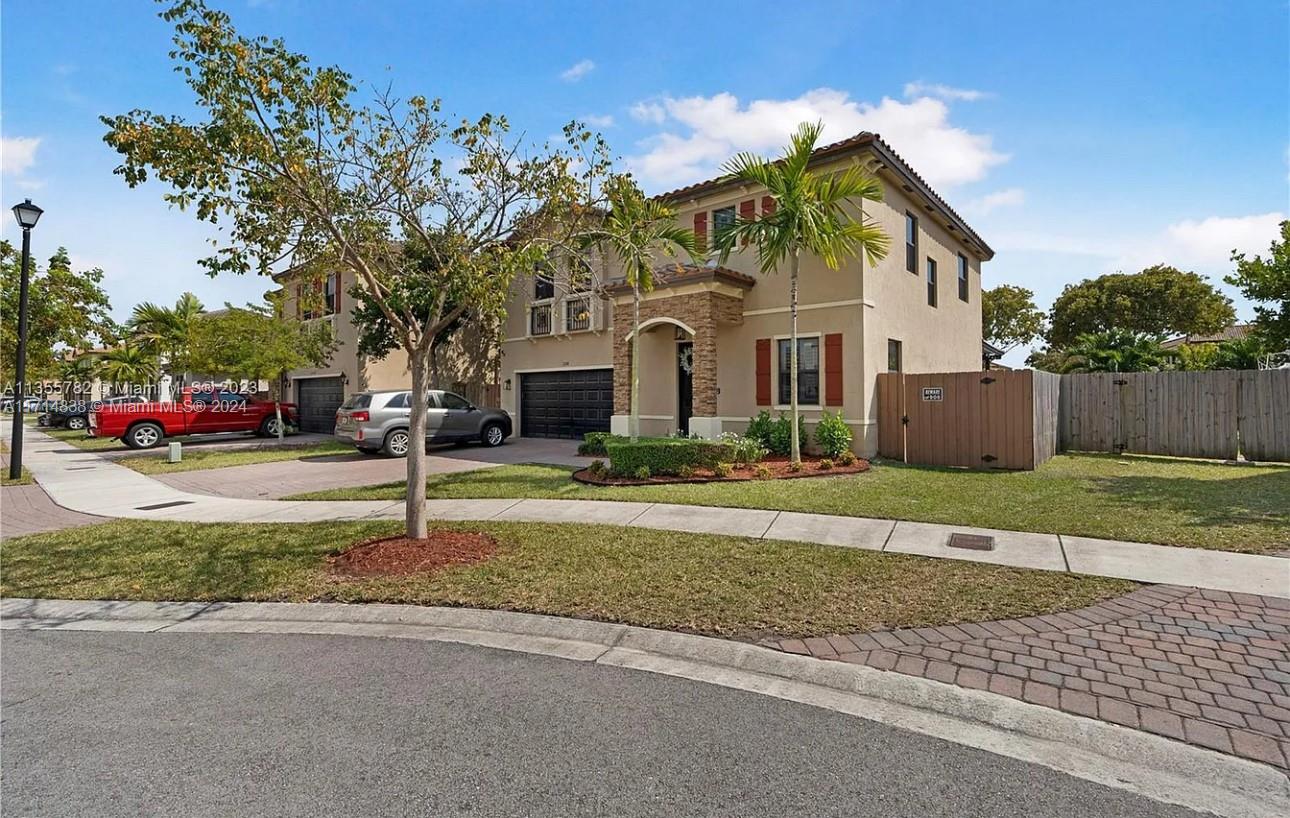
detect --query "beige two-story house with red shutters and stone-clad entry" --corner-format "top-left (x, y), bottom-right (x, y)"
top-left (501, 133), bottom-right (993, 454)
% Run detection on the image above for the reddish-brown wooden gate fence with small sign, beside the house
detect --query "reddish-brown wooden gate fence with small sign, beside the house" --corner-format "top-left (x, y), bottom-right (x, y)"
top-left (878, 370), bottom-right (1058, 470)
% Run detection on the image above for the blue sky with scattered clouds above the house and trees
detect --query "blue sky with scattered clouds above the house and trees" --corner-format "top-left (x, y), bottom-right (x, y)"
top-left (0, 0), bottom-right (1290, 360)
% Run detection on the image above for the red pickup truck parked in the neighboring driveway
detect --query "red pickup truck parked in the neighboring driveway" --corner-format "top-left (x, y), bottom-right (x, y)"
top-left (89, 388), bottom-right (297, 449)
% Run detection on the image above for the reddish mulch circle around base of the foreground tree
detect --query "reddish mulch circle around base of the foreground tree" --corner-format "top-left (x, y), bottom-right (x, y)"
top-left (328, 530), bottom-right (497, 577)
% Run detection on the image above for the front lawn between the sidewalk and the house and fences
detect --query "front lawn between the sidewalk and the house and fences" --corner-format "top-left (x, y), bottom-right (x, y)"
top-left (295, 454), bottom-right (1290, 554)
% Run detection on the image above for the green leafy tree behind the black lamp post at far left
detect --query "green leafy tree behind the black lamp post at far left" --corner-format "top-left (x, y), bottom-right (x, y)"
top-left (0, 241), bottom-right (116, 381)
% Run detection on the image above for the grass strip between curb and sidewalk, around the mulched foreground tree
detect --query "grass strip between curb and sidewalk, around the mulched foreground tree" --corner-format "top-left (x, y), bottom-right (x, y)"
top-left (0, 520), bottom-right (1136, 637)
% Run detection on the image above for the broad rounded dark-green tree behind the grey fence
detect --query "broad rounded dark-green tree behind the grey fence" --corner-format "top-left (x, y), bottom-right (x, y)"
top-left (1046, 264), bottom-right (1236, 350)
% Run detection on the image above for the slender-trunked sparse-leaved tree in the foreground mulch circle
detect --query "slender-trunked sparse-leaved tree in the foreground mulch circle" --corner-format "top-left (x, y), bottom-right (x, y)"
top-left (103, 0), bottom-right (604, 538)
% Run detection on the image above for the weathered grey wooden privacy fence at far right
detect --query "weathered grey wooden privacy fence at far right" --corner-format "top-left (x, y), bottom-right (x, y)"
top-left (1058, 369), bottom-right (1290, 461)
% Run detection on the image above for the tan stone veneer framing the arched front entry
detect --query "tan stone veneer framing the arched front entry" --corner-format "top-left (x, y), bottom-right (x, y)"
top-left (614, 292), bottom-right (743, 417)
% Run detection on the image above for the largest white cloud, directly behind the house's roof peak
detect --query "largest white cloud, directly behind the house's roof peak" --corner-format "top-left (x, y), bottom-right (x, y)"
top-left (630, 88), bottom-right (1009, 187)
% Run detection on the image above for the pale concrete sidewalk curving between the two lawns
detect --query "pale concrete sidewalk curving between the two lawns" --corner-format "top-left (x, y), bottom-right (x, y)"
top-left (10, 430), bottom-right (1290, 599)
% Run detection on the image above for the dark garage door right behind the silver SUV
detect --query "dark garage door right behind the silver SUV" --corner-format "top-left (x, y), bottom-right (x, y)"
top-left (520, 369), bottom-right (614, 440)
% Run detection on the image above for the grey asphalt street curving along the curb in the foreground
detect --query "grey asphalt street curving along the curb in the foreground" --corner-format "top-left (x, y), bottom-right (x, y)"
top-left (0, 631), bottom-right (1196, 818)
